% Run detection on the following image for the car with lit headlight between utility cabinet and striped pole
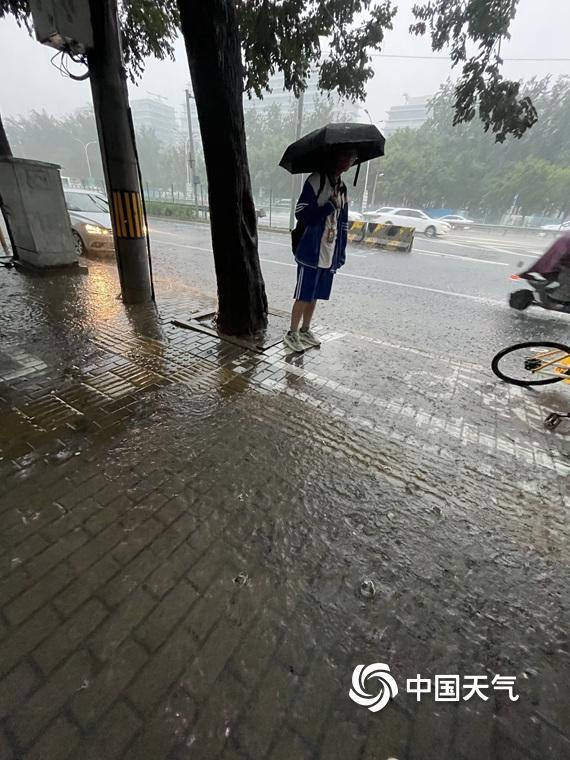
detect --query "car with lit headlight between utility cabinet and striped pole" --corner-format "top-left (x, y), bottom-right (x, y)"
top-left (64, 190), bottom-right (115, 256)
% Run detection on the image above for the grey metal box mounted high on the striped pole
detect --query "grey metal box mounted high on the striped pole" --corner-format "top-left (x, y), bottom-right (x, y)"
top-left (30, 0), bottom-right (93, 53)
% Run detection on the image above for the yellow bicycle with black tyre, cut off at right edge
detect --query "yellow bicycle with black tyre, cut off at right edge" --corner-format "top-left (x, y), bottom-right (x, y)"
top-left (491, 341), bottom-right (570, 430)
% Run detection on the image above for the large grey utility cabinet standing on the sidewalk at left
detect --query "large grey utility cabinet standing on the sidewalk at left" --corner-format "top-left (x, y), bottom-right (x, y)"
top-left (0, 158), bottom-right (79, 269)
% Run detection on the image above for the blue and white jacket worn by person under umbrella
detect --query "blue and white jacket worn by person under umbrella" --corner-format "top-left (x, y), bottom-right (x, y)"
top-left (295, 174), bottom-right (348, 272)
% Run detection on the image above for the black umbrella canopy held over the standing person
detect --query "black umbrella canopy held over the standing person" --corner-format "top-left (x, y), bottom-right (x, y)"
top-left (279, 123), bottom-right (385, 174)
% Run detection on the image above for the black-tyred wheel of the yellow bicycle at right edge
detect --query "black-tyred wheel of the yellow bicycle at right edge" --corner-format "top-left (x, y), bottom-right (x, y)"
top-left (491, 341), bottom-right (570, 387)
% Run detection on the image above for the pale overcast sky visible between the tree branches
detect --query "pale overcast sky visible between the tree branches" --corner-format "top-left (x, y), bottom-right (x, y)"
top-left (0, 0), bottom-right (570, 120)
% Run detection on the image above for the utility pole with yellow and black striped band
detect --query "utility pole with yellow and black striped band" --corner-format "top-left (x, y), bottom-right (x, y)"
top-left (87, 0), bottom-right (154, 303)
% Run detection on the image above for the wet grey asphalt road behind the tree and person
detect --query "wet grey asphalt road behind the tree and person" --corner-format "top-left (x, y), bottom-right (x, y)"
top-left (151, 219), bottom-right (570, 365)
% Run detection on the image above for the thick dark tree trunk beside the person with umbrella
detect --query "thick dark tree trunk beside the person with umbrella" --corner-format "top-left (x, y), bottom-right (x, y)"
top-left (178, 0), bottom-right (267, 335)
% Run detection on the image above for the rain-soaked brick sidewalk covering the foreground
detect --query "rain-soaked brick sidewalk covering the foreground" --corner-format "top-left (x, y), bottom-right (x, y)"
top-left (0, 256), bottom-right (570, 760)
